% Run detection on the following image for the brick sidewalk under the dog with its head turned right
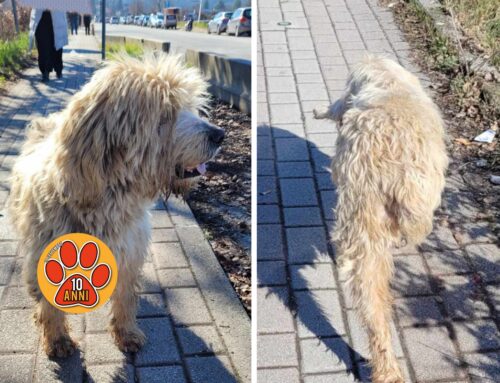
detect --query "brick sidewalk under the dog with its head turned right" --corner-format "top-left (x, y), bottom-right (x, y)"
top-left (0, 35), bottom-right (250, 383)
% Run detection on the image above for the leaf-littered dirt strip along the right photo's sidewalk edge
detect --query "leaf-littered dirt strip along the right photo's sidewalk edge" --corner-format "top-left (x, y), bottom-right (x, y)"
top-left (392, 2), bottom-right (500, 240)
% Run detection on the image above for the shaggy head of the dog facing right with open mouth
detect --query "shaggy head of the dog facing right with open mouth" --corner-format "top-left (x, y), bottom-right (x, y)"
top-left (57, 54), bottom-right (224, 206)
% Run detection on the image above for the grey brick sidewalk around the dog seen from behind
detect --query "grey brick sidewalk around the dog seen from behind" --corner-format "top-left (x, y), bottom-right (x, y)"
top-left (257, 0), bottom-right (500, 383)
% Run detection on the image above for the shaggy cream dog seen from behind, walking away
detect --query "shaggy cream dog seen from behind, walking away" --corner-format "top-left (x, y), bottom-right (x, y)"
top-left (315, 56), bottom-right (448, 383)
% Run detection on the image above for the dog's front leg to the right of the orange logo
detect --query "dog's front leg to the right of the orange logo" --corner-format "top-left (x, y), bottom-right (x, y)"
top-left (111, 257), bottom-right (146, 352)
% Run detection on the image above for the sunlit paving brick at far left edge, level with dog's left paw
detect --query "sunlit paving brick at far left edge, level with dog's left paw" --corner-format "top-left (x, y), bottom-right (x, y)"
top-left (0, 309), bottom-right (39, 353)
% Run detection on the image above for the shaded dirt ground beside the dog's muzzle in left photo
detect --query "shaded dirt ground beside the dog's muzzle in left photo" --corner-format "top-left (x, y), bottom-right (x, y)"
top-left (187, 102), bottom-right (251, 314)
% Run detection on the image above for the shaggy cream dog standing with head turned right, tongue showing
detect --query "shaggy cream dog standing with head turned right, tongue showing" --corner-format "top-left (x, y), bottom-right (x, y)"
top-left (9, 54), bottom-right (224, 357)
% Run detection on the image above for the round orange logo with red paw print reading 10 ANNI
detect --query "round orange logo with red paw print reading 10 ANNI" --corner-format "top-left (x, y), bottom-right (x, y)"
top-left (38, 233), bottom-right (117, 313)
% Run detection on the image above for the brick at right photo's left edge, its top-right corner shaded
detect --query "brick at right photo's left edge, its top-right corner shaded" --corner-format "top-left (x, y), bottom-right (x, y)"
top-left (257, 287), bottom-right (295, 333)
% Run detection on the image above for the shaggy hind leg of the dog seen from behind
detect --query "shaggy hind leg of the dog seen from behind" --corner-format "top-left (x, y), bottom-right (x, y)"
top-left (333, 196), bottom-right (403, 382)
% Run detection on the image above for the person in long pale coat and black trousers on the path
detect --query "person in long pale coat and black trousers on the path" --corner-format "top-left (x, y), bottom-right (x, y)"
top-left (30, 9), bottom-right (68, 82)
